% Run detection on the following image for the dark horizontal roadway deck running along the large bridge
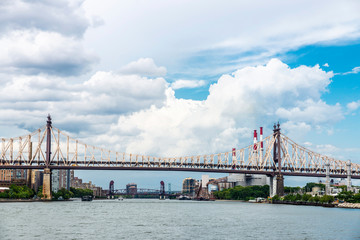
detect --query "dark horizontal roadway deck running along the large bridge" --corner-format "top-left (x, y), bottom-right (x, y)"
top-left (0, 164), bottom-right (360, 179)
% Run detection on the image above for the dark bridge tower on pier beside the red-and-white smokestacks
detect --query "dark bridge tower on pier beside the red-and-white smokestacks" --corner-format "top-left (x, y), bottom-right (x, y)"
top-left (270, 123), bottom-right (284, 196)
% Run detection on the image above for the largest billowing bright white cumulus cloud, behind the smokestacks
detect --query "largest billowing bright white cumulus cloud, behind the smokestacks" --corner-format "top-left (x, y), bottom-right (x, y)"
top-left (94, 59), bottom-right (342, 156)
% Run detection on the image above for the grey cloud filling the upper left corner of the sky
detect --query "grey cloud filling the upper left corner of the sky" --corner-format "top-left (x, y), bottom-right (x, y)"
top-left (0, 0), bottom-right (90, 37)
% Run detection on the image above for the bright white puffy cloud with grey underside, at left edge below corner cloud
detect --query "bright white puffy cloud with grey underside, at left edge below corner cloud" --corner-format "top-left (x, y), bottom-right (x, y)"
top-left (0, 30), bottom-right (97, 76)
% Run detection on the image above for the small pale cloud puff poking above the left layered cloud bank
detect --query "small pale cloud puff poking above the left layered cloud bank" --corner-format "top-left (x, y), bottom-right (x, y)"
top-left (120, 58), bottom-right (166, 76)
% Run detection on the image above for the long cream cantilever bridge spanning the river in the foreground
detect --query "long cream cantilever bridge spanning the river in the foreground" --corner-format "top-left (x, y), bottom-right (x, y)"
top-left (0, 115), bottom-right (360, 199)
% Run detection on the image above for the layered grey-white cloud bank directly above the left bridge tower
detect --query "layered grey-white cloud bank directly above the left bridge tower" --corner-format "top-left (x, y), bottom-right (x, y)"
top-left (0, 69), bottom-right (168, 135)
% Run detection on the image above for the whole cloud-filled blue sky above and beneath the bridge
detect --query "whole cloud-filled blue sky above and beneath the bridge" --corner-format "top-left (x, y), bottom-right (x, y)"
top-left (0, 0), bottom-right (360, 189)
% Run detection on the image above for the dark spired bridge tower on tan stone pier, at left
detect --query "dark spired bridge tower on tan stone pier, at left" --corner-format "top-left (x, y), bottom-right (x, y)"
top-left (42, 114), bottom-right (52, 200)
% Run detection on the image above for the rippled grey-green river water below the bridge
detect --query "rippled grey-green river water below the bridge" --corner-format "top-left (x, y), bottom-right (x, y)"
top-left (0, 199), bottom-right (360, 240)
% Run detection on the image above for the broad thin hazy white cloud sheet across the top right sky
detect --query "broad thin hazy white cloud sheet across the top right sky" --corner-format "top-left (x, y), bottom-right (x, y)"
top-left (84, 0), bottom-right (360, 76)
